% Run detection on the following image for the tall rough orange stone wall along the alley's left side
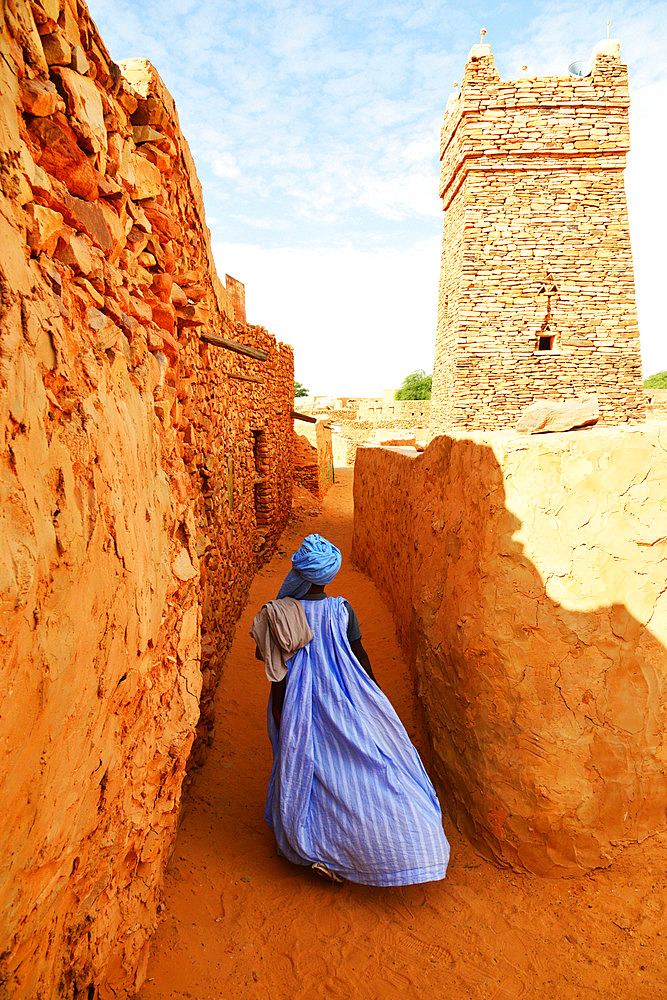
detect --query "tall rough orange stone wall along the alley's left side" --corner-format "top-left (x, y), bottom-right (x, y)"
top-left (0, 0), bottom-right (293, 1000)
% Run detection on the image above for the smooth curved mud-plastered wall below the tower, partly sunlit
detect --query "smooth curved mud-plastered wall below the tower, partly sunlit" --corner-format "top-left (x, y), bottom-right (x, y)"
top-left (353, 425), bottom-right (667, 876)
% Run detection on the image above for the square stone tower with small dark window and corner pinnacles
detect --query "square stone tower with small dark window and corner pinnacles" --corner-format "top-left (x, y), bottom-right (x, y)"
top-left (432, 41), bottom-right (644, 430)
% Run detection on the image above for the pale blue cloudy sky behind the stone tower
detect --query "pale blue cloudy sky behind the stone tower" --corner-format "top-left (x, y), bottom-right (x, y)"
top-left (89, 0), bottom-right (667, 395)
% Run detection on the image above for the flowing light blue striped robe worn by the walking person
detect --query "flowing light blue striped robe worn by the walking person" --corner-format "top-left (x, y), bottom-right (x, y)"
top-left (266, 597), bottom-right (449, 886)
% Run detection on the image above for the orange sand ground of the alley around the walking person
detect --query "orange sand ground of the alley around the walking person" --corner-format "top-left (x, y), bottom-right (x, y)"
top-left (139, 470), bottom-right (667, 1000)
